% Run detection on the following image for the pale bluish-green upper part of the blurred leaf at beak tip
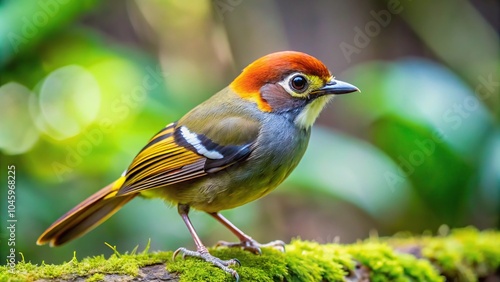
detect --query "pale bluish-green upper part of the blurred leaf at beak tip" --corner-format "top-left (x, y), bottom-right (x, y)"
top-left (347, 59), bottom-right (493, 161)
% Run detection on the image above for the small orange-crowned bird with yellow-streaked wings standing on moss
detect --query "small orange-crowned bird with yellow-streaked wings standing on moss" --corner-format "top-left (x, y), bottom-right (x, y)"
top-left (37, 51), bottom-right (359, 281)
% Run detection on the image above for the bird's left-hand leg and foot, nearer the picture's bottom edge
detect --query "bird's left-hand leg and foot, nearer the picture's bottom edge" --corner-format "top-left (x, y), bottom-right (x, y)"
top-left (173, 204), bottom-right (241, 281)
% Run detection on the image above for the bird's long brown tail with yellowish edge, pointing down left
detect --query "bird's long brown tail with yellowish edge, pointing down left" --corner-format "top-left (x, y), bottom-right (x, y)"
top-left (36, 177), bottom-right (138, 246)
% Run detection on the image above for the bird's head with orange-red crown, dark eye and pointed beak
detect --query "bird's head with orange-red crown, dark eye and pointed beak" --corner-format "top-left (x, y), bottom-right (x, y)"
top-left (230, 51), bottom-right (359, 128)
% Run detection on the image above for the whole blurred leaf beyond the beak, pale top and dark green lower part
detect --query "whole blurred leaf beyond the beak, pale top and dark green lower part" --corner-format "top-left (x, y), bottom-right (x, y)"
top-left (347, 59), bottom-right (493, 225)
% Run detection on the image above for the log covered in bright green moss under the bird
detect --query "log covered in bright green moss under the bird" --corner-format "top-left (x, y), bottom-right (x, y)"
top-left (0, 228), bottom-right (500, 281)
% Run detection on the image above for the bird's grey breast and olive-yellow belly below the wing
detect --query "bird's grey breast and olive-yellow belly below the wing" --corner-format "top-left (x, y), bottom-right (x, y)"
top-left (195, 115), bottom-right (309, 211)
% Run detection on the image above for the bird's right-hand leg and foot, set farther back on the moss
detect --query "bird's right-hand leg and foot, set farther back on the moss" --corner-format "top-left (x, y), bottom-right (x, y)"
top-left (208, 212), bottom-right (285, 255)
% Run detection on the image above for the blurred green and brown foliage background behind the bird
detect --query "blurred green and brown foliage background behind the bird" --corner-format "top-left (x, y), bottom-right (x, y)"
top-left (0, 0), bottom-right (500, 263)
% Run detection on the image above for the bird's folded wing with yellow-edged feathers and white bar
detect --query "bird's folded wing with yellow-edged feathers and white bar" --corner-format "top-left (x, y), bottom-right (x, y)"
top-left (116, 118), bottom-right (259, 195)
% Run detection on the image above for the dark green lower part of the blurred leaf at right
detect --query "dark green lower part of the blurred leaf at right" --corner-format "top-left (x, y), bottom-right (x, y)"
top-left (371, 116), bottom-right (473, 226)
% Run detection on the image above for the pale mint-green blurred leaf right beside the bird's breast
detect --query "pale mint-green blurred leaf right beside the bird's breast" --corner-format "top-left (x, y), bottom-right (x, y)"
top-left (285, 127), bottom-right (411, 222)
